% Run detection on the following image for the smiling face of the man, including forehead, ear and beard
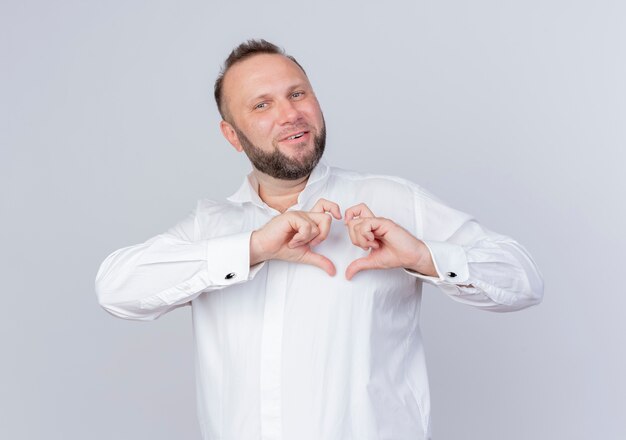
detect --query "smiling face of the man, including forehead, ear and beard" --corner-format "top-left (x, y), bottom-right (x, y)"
top-left (221, 54), bottom-right (326, 180)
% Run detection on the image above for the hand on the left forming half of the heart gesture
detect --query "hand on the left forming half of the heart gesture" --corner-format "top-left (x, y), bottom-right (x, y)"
top-left (250, 199), bottom-right (341, 276)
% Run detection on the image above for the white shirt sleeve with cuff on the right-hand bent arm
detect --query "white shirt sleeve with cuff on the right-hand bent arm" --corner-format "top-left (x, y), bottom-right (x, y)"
top-left (406, 188), bottom-right (543, 312)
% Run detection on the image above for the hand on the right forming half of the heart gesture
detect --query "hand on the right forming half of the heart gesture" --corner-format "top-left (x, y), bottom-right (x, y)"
top-left (344, 203), bottom-right (437, 280)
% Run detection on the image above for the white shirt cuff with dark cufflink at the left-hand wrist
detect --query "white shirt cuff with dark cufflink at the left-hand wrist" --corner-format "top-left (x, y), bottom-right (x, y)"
top-left (206, 231), bottom-right (264, 286)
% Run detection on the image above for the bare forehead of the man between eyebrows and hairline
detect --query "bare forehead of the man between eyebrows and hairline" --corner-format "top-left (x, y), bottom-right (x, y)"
top-left (223, 54), bottom-right (310, 105)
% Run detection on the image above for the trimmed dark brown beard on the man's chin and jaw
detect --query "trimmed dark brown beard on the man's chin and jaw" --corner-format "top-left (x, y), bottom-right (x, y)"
top-left (233, 119), bottom-right (326, 180)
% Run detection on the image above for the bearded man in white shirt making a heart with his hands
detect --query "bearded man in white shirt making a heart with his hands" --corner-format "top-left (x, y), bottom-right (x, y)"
top-left (96, 40), bottom-right (543, 440)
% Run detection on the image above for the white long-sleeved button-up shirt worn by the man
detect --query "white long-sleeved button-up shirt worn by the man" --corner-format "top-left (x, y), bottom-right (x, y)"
top-left (96, 162), bottom-right (543, 440)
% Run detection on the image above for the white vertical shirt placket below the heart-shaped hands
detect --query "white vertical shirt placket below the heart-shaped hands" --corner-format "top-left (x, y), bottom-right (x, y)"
top-left (260, 260), bottom-right (288, 440)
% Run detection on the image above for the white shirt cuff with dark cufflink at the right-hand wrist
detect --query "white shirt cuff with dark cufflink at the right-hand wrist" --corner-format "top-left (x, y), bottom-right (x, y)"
top-left (404, 240), bottom-right (471, 285)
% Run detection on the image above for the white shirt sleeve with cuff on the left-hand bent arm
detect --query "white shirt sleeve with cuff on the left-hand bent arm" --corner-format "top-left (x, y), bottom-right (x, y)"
top-left (96, 208), bottom-right (263, 320)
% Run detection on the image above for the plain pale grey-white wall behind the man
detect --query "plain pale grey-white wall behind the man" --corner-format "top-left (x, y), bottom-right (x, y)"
top-left (0, 0), bottom-right (626, 440)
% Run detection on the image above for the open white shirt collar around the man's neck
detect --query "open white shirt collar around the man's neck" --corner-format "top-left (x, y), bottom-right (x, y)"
top-left (227, 159), bottom-right (330, 209)
